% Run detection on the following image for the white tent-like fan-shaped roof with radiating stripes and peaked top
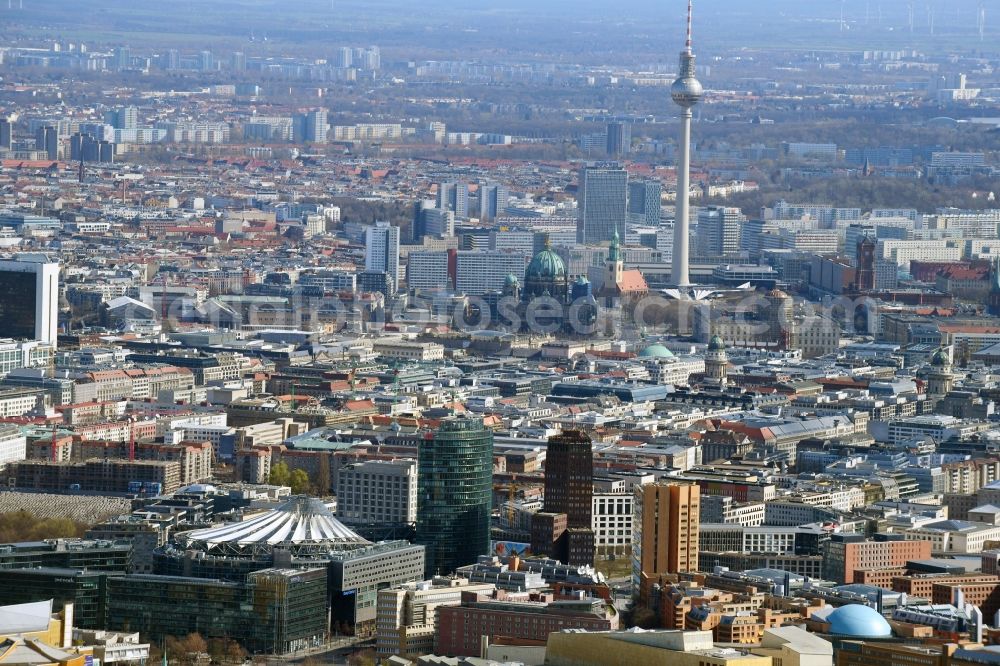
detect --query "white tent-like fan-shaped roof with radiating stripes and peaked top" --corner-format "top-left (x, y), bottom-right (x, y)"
top-left (177, 496), bottom-right (369, 551)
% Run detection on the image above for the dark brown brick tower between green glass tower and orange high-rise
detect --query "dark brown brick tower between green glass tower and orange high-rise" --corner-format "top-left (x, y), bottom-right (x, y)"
top-left (531, 430), bottom-right (594, 565)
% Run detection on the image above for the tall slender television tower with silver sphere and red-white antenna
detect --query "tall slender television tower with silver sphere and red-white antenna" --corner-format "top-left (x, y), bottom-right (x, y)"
top-left (670, 0), bottom-right (704, 287)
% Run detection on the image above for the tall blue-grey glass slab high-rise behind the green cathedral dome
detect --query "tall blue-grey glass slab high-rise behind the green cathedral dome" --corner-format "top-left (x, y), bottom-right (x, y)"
top-left (576, 162), bottom-right (628, 244)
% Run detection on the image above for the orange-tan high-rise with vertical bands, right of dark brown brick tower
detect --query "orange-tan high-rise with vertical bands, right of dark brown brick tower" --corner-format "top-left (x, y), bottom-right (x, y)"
top-left (632, 483), bottom-right (701, 603)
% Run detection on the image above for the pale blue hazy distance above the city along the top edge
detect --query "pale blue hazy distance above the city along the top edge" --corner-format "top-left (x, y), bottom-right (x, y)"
top-left (0, 0), bottom-right (1000, 54)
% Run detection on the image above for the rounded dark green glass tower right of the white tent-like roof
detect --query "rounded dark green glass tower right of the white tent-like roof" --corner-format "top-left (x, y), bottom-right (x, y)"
top-left (415, 416), bottom-right (493, 576)
